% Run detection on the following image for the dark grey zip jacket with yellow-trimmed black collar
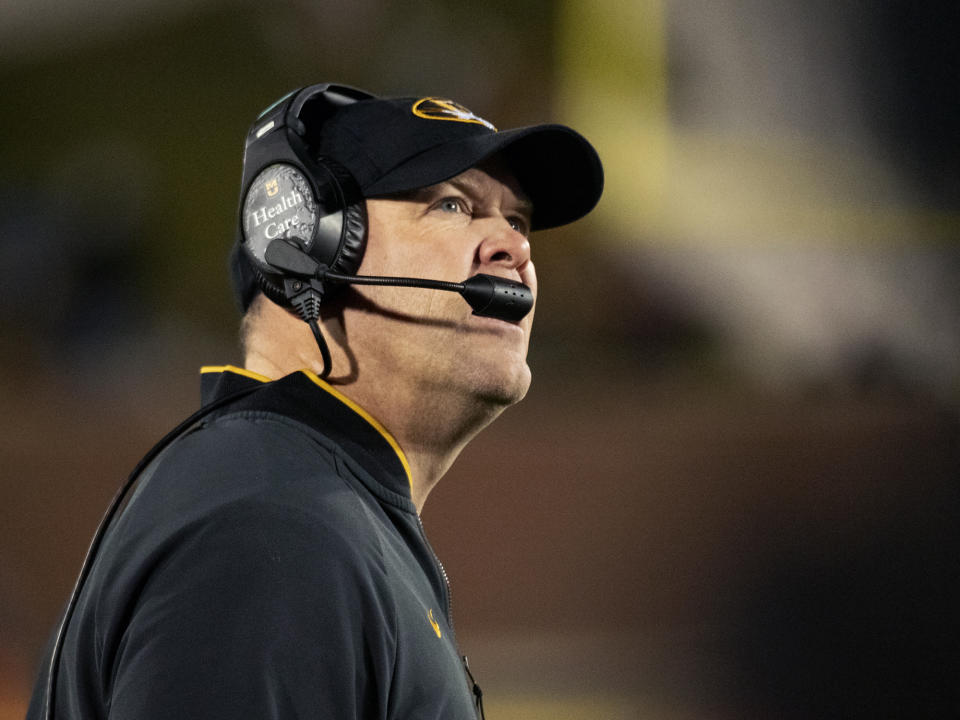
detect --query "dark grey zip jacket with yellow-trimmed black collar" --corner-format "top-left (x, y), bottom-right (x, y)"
top-left (28, 367), bottom-right (475, 720)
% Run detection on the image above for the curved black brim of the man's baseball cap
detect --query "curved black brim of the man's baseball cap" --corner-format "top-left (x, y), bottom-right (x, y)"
top-left (363, 125), bottom-right (603, 230)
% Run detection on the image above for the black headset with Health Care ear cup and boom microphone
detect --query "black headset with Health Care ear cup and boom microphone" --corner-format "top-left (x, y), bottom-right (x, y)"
top-left (237, 83), bottom-right (533, 378)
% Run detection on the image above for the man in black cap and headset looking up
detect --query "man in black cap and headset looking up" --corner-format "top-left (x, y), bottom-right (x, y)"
top-left (29, 85), bottom-right (602, 720)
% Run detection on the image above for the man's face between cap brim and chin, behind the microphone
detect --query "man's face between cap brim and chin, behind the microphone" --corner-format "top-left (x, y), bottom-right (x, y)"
top-left (344, 164), bottom-right (537, 405)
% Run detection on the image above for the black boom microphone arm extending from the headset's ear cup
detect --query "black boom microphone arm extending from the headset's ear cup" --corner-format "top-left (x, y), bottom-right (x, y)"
top-left (264, 238), bottom-right (533, 322)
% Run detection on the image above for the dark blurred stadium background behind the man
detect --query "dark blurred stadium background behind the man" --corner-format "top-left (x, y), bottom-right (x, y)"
top-left (0, 0), bottom-right (960, 720)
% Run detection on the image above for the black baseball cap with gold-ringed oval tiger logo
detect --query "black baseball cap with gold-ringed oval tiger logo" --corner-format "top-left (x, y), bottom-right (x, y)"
top-left (231, 86), bottom-right (603, 309)
